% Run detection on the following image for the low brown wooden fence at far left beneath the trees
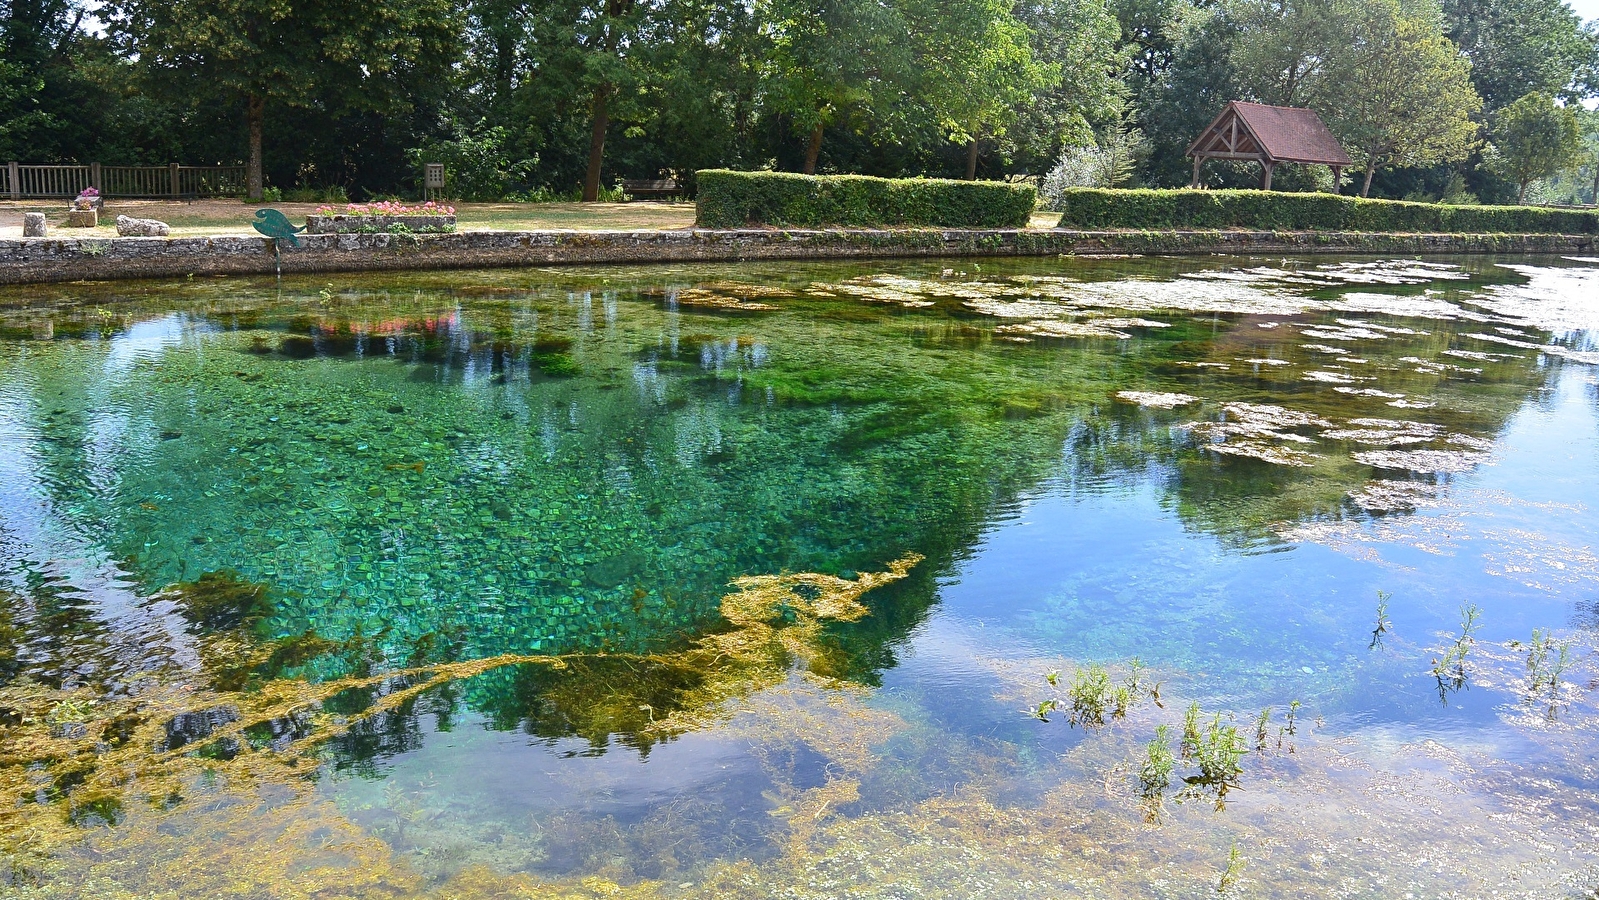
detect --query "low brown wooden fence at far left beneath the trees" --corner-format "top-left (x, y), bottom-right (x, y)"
top-left (0, 163), bottom-right (245, 200)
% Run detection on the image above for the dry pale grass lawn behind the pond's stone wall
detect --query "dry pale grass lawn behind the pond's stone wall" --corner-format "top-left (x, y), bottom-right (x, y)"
top-left (0, 200), bottom-right (1060, 238)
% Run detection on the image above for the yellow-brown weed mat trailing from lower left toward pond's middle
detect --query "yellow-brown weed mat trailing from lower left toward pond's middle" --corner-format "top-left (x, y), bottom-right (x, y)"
top-left (0, 555), bottom-right (921, 886)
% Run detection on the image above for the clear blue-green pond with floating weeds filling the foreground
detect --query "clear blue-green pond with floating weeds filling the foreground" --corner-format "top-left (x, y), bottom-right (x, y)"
top-left (0, 257), bottom-right (1599, 900)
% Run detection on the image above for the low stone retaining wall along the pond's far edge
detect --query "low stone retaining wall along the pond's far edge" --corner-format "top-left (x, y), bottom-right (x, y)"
top-left (0, 229), bottom-right (1596, 285)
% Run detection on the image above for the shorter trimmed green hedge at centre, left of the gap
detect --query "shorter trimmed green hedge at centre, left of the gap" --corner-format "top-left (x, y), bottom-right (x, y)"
top-left (694, 169), bottom-right (1038, 229)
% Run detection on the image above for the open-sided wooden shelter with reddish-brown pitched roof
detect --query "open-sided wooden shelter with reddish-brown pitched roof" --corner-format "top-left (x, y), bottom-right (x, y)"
top-left (1188, 101), bottom-right (1354, 190)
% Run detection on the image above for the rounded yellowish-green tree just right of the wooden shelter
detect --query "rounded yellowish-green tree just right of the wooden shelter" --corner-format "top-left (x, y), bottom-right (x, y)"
top-left (1319, 0), bottom-right (1482, 197)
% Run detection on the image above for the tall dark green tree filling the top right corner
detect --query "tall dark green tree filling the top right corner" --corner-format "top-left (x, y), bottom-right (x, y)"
top-left (1444, 0), bottom-right (1596, 112)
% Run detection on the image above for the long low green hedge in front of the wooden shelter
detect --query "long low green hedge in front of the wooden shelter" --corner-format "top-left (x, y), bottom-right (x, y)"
top-left (1060, 187), bottom-right (1599, 235)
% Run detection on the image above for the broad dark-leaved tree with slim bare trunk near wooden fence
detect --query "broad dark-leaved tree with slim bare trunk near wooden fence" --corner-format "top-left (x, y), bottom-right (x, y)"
top-left (101, 0), bottom-right (461, 200)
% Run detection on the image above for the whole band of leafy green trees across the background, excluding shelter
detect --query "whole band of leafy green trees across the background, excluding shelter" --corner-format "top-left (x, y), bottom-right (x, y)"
top-left (0, 0), bottom-right (1599, 203)
